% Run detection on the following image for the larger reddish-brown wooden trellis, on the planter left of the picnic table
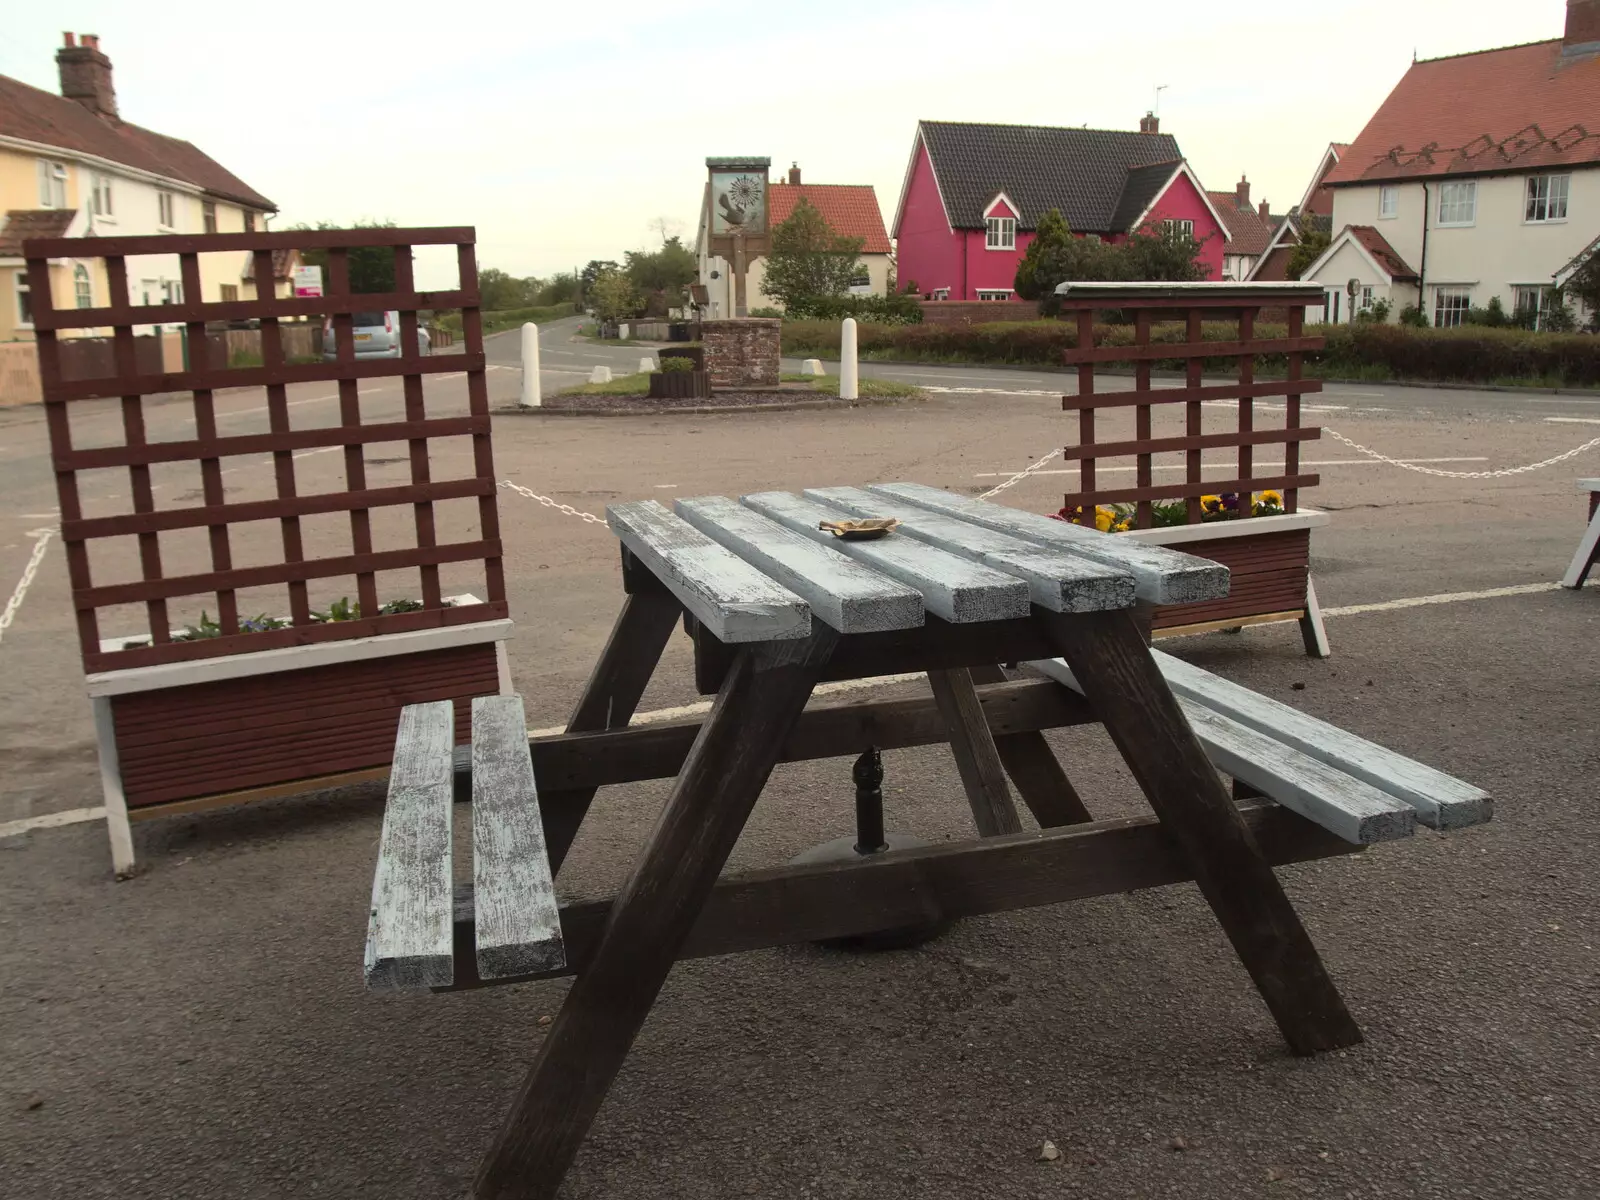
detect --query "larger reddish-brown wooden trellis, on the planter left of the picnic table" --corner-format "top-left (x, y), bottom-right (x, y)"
top-left (24, 227), bottom-right (507, 672)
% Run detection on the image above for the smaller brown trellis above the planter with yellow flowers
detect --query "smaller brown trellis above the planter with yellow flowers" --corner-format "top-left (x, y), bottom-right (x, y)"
top-left (1061, 283), bottom-right (1323, 530)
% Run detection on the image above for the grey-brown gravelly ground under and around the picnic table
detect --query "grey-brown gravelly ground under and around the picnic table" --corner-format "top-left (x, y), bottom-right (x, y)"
top-left (0, 371), bottom-right (1600, 1200)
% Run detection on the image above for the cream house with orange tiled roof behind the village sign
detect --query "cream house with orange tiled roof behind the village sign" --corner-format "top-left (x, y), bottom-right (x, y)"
top-left (694, 166), bottom-right (894, 317)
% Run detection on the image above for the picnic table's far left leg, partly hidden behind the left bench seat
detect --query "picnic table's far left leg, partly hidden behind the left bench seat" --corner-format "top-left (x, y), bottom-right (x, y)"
top-left (539, 581), bottom-right (683, 875)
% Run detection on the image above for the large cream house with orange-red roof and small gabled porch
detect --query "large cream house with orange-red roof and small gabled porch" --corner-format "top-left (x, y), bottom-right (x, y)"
top-left (1302, 0), bottom-right (1600, 326)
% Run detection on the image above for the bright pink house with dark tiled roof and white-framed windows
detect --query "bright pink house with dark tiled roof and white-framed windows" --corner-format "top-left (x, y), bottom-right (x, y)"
top-left (894, 115), bottom-right (1229, 301)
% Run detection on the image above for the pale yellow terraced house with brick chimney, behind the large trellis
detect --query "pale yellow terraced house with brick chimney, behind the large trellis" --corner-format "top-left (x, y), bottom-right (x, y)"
top-left (0, 34), bottom-right (277, 342)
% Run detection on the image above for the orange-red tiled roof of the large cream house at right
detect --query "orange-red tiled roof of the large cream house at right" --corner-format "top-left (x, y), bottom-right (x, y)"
top-left (1328, 40), bottom-right (1600, 184)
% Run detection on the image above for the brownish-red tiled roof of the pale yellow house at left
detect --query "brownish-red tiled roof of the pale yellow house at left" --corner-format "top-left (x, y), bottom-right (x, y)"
top-left (0, 75), bottom-right (277, 213)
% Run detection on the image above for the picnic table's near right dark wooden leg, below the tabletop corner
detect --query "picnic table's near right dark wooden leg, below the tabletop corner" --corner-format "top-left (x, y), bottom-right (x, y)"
top-left (1035, 610), bottom-right (1362, 1054)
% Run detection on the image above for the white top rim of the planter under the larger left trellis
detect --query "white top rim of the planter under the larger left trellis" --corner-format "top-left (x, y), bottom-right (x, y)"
top-left (85, 619), bottom-right (512, 696)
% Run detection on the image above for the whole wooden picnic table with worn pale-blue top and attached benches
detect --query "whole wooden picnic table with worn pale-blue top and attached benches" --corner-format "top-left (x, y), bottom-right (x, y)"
top-left (366, 483), bottom-right (1490, 1197)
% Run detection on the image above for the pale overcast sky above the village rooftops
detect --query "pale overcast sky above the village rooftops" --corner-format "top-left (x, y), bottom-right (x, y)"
top-left (0, 0), bottom-right (1565, 286)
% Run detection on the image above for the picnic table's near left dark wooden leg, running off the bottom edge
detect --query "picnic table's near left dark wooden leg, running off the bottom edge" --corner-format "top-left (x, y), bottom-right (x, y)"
top-left (475, 622), bottom-right (838, 1200)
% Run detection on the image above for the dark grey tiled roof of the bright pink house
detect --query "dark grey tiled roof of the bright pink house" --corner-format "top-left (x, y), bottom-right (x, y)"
top-left (918, 122), bottom-right (1182, 234)
